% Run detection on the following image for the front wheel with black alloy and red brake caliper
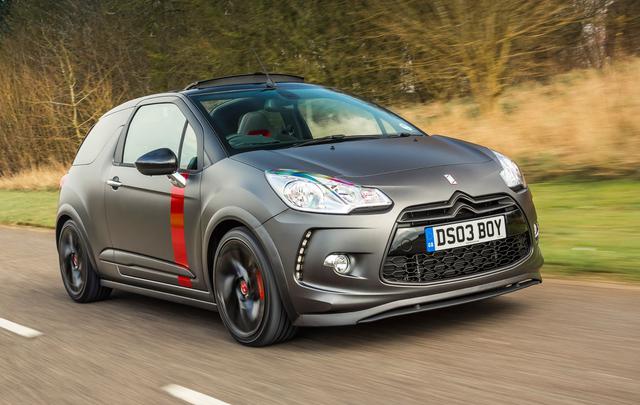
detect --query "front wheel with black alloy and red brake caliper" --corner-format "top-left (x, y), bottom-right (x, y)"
top-left (213, 227), bottom-right (296, 346)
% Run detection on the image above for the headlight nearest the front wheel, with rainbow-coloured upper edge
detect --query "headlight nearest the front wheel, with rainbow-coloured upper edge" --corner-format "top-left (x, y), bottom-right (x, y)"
top-left (265, 170), bottom-right (393, 214)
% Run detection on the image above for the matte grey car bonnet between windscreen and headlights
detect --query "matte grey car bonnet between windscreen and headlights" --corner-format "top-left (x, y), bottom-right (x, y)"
top-left (232, 135), bottom-right (492, 178)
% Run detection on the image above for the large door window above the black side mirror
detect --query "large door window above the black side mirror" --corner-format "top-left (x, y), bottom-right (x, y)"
top-left (122, 103), bottom-right (187, 164)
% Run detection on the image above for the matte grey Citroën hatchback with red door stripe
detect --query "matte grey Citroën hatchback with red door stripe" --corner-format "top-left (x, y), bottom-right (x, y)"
top-left (56, 73), bottom-right (543, 346)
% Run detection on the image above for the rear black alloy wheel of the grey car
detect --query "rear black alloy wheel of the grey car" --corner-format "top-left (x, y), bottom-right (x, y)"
top-left (58, 220), bottom-right (111, 302)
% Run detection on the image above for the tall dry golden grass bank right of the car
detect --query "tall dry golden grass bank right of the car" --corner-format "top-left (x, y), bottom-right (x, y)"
top-left (395, 58), bottom-right (640, 181)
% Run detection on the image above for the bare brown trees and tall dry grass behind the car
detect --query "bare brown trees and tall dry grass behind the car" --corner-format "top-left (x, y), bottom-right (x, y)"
top-left (0, 0), bottom-right (640, 180)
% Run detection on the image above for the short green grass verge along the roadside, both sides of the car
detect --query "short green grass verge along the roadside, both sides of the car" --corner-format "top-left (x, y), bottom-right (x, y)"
top-left (0, 180), bottom-right (640, 281)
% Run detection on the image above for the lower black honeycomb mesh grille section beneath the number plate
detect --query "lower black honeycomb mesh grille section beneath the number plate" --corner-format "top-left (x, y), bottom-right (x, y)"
top-left (382, 233), bottom-right (530, 283)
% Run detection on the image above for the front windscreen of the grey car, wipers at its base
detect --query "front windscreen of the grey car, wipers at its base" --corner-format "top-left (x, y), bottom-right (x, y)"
top-left (191, 86), bottom-right (423, 153)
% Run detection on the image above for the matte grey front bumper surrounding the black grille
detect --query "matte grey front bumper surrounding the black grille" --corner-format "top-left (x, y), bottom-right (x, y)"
top-left (262, 164), bottom-right (543, 326)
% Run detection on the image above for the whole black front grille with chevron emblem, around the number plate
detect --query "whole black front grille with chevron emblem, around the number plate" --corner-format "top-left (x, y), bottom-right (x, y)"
top-left (381, 192), bottom-right (531, 283)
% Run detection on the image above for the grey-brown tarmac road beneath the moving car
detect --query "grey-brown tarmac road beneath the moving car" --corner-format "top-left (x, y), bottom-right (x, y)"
top-left (0, 228), bottom-right (640, 405)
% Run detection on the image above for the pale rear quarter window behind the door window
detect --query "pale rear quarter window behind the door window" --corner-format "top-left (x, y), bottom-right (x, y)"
top-left (73, 109), bottom-right (131, 166)
